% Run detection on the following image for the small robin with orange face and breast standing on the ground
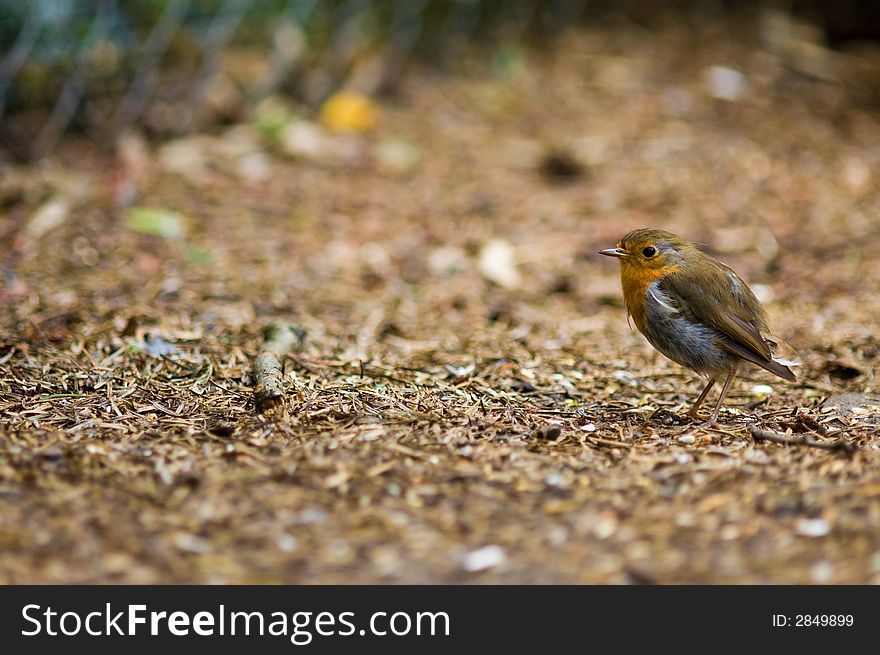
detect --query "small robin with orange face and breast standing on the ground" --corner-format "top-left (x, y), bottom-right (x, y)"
top-left (599, 228), bottom-right (800, 428)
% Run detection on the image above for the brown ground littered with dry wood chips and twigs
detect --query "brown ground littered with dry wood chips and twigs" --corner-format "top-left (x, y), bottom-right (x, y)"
top-left (0, 17), bottom-right (880, 584)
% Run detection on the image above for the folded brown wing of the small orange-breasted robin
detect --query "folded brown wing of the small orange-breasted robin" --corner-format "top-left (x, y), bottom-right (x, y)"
top-left (659, 263), bottom-right (796, 381)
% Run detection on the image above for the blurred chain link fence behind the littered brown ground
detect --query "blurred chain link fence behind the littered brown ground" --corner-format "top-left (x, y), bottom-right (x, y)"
top-left (0, 0), bottom-right (596, 159)
